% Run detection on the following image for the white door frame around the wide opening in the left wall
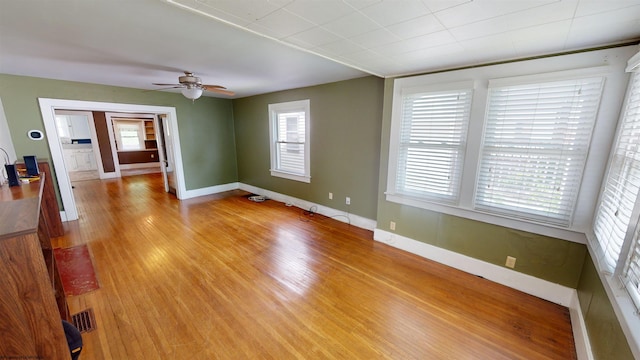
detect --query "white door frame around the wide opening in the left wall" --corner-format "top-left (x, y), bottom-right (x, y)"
top-left (38, 98), bottom-right (186, 221)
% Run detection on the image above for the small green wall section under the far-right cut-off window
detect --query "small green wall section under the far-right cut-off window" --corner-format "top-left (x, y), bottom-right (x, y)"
top-left (578, 254), bottom-right (634, 360)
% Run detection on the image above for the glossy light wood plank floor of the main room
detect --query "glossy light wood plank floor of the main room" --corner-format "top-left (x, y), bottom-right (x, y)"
top-left (54, 174), bottom-right (576, 360)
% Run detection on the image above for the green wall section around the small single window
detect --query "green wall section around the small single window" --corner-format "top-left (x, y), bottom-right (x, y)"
top-left (233, 76), bottom-right (383, 219)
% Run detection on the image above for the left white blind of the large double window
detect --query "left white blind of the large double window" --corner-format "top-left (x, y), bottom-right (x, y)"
top-left (395, 89), bottom-right (472, 203)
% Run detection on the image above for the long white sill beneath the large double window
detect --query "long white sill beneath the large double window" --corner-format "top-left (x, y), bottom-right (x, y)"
top-left (386, 194), bottom-right (587, 244)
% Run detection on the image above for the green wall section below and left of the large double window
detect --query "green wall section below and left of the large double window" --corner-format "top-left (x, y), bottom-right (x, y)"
top-left (376, 79), bottom-right (587, 288)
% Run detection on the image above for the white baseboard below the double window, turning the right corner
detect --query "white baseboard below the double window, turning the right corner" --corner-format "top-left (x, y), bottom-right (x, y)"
top-left (373, 229), bottom-right (593, 360)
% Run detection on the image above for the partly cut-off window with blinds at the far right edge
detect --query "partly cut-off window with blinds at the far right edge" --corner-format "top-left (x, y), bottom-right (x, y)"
top-left (593, 73), bottom-right (640, 307)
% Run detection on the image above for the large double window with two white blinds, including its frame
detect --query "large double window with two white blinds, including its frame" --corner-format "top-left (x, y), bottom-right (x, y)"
top-left (385, 65), bottom-right (626, 242)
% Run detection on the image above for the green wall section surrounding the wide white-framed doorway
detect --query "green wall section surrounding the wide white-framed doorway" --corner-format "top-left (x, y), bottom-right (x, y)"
top-left (0, 74), bottom-right (237, 194)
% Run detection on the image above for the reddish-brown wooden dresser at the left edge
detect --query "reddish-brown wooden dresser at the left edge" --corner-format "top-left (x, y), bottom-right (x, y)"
top-left (0, 173), bottom-right (70, 359)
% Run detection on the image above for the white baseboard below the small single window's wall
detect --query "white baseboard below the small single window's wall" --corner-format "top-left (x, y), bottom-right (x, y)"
top-left (240, 183), bottom-right (377, 231)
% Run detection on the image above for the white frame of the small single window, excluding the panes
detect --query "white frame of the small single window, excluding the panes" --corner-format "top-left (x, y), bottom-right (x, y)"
top-left (268, 99), bottom-right (311, 183)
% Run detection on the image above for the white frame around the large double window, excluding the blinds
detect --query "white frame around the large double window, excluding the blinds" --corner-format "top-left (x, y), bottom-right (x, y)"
top-left (385, 65), bottom-right (615, 244)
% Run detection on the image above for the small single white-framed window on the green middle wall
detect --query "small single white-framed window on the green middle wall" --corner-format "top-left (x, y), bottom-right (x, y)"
top-left (269, 100), bottom-right (311, 182)
